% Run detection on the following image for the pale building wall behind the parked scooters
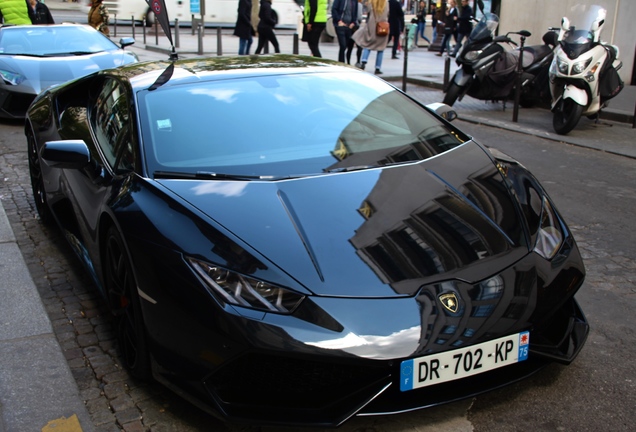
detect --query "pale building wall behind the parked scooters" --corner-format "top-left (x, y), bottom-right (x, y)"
top-left (499, 0), bottom-right (636, 84)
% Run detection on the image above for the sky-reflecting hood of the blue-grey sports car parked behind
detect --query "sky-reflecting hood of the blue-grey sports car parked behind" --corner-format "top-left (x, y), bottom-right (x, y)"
top-left (0, 50), bottom-right (137, 94)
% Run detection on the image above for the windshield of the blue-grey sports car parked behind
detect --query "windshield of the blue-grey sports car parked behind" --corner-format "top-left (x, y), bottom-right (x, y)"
top-left (0, 25), bottom-right (118, 57)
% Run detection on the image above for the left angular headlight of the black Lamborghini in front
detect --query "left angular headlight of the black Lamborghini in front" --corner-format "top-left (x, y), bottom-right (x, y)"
top-left (188, 258), bottom-right (305, 314)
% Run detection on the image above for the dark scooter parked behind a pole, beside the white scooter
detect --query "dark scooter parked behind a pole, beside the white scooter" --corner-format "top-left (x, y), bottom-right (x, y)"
top-left (444, 13), bottom-right (557, 107)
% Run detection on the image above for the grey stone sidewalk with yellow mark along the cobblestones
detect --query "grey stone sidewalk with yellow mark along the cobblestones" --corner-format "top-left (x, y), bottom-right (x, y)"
top-left (0, 202), bottom-right (93, 432)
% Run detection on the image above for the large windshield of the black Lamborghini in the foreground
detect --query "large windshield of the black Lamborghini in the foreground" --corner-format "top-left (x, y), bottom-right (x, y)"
top-left (138, 71), bottom-right (468, 178)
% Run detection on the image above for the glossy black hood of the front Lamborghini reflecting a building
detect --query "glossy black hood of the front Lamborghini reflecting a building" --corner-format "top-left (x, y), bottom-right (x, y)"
top-left (158, 141), bottom-right (528, 297)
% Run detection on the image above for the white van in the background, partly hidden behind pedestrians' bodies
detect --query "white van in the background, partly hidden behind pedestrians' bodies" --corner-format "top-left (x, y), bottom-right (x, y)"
top-left (81, 0), bottom-right (302, 28)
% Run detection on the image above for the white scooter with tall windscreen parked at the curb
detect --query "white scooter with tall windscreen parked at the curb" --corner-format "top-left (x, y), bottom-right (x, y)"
top-left (550, 6), bottom-right (624, 135)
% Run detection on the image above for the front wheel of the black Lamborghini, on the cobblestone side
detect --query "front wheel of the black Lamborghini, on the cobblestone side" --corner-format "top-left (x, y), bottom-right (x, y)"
top-left (104, 227), bottom-right (152, 380)
